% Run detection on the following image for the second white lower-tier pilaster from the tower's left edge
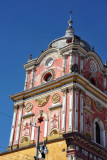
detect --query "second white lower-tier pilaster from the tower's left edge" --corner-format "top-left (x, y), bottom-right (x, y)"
top-left (15, 104), bottom-right (23, 144)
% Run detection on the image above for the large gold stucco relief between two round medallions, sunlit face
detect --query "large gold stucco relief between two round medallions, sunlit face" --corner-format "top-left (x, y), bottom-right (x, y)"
top-left (36, 95), bottom-right (50, 107)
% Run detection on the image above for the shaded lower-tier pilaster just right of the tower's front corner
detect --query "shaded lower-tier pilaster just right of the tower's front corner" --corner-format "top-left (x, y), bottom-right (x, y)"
top-left (74, 90), bottom-right (78, 131)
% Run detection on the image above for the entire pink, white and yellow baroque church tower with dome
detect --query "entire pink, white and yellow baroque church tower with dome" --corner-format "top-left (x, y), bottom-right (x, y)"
top-left (0, 15), bottom-right (107, 160)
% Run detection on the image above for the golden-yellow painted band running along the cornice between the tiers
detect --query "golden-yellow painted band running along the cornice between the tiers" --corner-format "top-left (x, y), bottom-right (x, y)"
top-left (10, 75), bottom-right (107, 103)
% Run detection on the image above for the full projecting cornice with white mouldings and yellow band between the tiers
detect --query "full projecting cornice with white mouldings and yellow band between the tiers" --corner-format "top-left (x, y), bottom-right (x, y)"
top-left (10, 73), bottom-right (107, 107)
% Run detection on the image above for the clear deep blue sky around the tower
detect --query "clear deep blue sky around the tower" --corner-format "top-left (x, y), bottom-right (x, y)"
top-left (0, 0), bottom-right (107, 152)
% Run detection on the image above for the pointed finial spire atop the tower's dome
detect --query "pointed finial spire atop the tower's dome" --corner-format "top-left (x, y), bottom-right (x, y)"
top-left (65, 11), bottom-right (74, 37)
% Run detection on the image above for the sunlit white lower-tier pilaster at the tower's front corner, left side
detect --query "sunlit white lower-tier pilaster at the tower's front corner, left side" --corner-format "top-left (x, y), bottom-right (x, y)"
top-left (68, 88), bottom-right (73, 131)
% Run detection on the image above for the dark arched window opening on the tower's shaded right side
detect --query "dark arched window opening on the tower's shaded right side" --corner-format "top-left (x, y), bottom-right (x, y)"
top-left (94, 118), bottom-right (105, 146)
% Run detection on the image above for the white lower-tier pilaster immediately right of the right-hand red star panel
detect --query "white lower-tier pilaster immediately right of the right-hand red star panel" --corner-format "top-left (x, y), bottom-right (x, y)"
top-left (61, 89), bottom-right (66, 132)
